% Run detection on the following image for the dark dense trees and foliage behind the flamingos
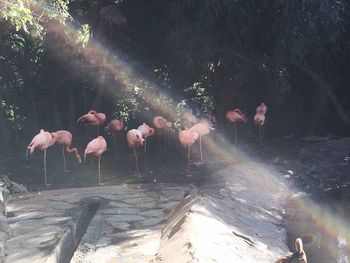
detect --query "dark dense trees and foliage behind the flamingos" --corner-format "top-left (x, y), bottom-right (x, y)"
top-left (0, 0), bottom-right (350, 151)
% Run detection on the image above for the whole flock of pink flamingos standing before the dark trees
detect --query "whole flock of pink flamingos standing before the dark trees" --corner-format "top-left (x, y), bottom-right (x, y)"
top-left (26, 103), bottom-right (267, 185)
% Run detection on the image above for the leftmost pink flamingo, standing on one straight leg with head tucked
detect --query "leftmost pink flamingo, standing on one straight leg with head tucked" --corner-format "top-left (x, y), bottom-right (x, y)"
top-left (26, 129), bottom-right (57, 186)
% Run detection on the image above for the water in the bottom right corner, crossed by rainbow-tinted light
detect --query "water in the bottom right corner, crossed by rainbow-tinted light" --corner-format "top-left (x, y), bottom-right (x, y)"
top-left (283, 187), bottom-right (350, 263)
